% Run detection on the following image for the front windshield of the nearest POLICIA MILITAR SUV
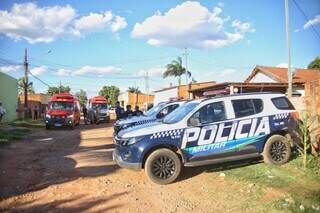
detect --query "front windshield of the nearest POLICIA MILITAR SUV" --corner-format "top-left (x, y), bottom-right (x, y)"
top-left (163, 102), bottom-right (199, 124)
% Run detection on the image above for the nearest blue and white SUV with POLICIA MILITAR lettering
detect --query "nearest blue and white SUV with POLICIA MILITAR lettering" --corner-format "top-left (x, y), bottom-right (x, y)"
top-left (113, 93), bottom-right (297, 184)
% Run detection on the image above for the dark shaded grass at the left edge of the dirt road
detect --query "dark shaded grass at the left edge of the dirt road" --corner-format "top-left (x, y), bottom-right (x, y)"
top-left (0, 128), bottom-right (32, 145)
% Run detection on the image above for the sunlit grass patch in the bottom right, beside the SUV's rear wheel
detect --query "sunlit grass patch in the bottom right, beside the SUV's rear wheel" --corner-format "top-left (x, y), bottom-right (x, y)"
top-left (208, 156), bottom-right (320, 212)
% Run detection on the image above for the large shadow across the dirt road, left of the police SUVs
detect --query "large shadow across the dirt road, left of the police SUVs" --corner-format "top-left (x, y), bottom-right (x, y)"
top-left (0, 120), bottom-right (119, 201)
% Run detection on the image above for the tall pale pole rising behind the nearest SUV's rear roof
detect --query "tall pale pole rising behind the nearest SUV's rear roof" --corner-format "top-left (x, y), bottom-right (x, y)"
top-left (285, 0), bottom-right (292, 98)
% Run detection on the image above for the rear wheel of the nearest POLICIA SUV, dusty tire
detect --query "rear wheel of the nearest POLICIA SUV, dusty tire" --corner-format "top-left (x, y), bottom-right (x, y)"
top-left (262, 135), bottom-right (291, 165)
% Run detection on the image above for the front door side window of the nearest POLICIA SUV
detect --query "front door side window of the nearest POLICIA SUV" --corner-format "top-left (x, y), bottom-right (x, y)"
top-left (192, 101), bottom-right (227, 124)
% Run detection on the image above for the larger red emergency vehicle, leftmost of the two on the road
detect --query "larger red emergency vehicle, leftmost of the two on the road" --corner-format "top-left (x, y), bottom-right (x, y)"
top-left (45, 93), bottom-right (80, 129)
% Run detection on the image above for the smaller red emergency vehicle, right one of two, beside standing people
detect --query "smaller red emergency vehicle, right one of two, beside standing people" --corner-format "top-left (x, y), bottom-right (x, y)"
top-left (86, 96), bottom-right (110, 124)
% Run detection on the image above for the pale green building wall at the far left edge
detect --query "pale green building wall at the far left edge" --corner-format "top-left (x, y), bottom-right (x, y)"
top-left (0, 72), bottom-right (18, 122)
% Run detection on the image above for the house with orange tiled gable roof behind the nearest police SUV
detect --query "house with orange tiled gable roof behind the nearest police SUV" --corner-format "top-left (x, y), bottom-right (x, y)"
top-left (190, 66), bottom-right (320, 110)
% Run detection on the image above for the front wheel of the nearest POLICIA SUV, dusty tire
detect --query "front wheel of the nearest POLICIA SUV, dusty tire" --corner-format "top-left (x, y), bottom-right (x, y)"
top-left (144, 149), bottom-right (181, 185)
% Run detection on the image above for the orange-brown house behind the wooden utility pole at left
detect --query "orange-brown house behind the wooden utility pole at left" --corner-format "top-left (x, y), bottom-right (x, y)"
top-left (18, 93), bottom-right (50, 118)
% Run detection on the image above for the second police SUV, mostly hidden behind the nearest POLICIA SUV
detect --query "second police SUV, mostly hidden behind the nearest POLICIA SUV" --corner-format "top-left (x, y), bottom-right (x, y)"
top-left (114, 101), bottom-right (185, 134)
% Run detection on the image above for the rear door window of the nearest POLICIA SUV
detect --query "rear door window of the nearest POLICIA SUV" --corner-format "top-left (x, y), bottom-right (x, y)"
top-left (231, 99), bottom-right (263, 118)
